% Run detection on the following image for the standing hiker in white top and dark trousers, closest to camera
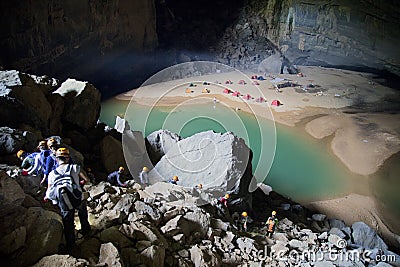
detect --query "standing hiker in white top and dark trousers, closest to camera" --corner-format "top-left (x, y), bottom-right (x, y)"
top-left (44, 147), bottom-right (91, 251)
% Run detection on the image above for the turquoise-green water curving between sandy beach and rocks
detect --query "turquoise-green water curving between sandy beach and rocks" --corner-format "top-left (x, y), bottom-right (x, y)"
top-left (100, 100), bottom-right (362, 202)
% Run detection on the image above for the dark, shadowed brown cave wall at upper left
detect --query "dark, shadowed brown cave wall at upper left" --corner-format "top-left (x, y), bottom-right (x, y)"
top-left (0, 0), bottom-right (158, 71)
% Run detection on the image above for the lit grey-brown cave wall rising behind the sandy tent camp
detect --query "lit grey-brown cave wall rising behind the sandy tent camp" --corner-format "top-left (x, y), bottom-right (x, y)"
top-left (219, 0), bottom-right (400, 75)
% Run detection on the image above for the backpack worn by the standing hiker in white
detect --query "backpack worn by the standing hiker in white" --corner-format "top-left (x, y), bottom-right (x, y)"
top-left (54, 164), bottom-right (82, 211)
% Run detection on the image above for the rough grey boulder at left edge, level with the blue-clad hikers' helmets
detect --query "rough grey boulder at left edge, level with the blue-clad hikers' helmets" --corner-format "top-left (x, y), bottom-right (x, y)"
top-left (0, 127), bottom-right (37, 156)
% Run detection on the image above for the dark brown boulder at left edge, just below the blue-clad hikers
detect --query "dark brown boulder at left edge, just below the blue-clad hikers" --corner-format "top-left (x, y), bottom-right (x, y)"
top-left (0, 171), bottom-right (25, 205)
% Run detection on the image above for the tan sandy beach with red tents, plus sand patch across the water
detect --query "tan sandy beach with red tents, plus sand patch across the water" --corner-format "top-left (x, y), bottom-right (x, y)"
top-left (117, 67), bottom-right (400, 246)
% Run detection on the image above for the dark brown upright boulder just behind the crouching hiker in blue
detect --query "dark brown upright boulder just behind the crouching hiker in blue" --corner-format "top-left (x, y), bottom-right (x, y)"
top-left (99, 135), bottom-right (127, 173)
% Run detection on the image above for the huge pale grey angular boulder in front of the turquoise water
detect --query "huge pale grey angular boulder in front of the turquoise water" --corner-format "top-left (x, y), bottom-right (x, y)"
top-left (149, 131), bottom-right (251, 200)
